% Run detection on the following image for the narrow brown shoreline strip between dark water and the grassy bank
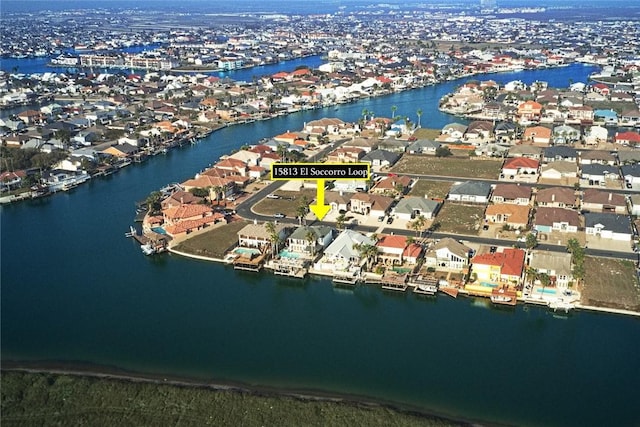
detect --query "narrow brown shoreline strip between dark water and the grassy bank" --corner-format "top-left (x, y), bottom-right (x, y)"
top-left (0, 360), bottom-right (480, 425)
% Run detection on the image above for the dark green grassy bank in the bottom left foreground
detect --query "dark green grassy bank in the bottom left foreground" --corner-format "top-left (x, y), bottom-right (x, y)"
top-left (2, 371), bottom-right (465, 426)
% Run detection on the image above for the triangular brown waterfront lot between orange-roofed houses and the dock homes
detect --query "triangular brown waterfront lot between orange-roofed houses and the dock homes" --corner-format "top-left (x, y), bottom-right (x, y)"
top-left (175, 221), bottom-right (248, 258)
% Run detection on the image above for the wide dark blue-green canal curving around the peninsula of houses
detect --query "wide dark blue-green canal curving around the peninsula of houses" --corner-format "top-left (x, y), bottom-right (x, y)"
top-left (0, 65), bottom-right (640, 426)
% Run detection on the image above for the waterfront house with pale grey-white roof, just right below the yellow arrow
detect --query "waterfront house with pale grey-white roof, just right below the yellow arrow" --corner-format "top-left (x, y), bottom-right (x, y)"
top-left (313, 230), bottom-right (376, 273)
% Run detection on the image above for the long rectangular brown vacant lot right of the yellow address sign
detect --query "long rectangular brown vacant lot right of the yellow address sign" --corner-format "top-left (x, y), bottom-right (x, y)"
top-left (391, 154), bottom-right (502, 179)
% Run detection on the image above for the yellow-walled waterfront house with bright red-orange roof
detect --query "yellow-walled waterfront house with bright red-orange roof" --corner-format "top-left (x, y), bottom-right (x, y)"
top-left (471, 248), bottom-right (525, 285)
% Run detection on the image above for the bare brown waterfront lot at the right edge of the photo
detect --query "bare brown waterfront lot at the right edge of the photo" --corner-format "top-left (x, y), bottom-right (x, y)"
top-left (581, 257), bottom-right (640, 311)
